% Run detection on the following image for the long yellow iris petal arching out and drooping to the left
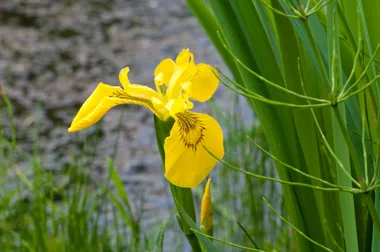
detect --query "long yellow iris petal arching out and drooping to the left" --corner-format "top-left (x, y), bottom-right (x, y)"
top-left (68, 83), bottom-right (156, 132)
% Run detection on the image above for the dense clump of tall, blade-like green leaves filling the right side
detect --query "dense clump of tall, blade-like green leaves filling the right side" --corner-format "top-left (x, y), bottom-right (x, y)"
top-left (187, 0), bottom-right (380, 251)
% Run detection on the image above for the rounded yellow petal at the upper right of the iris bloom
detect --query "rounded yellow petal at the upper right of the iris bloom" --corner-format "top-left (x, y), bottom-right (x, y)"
top-left (190, 64), bottom-right (219, 102)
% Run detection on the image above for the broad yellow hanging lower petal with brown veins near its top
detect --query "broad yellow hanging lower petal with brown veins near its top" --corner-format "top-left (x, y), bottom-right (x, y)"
top-left (164, 111), bottom-right (224, 188)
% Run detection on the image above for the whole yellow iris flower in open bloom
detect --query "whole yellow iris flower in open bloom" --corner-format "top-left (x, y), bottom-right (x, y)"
top-left (68, 49), bottom-right (224, 188)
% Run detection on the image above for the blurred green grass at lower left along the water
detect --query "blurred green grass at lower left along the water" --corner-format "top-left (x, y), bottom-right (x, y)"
top-left (0, 88), bottom-right (154, 251)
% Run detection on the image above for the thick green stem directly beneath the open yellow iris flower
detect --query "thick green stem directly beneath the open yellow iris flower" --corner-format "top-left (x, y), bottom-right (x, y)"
top-left (154, 116), bottom-right (202, 252)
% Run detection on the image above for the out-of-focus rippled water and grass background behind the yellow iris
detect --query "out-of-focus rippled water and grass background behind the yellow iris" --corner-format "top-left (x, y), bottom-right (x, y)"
top-left (0, 0), bottom-right (286, 251)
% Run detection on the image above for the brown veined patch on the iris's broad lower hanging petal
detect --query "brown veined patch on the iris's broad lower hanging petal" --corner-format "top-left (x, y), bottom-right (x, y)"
top-left (176, 112), bottom-right (206, 151)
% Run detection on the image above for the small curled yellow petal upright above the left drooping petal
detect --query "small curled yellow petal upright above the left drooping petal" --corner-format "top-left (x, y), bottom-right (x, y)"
top-left (119, 67), bottom-right (159, 100)
